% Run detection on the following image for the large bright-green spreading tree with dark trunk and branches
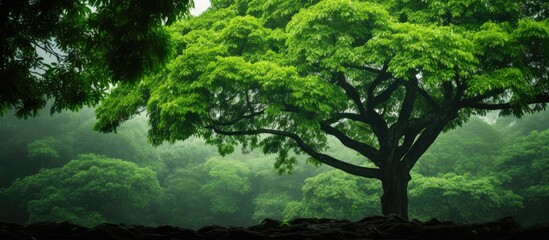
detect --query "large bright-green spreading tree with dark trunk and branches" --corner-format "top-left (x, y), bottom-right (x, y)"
top-left (95, 0), bottom-right (549, 217)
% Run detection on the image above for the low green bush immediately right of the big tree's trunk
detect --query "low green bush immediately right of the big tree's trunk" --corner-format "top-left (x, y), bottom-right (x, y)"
top-left (409, 173), bottom-right (524, 222)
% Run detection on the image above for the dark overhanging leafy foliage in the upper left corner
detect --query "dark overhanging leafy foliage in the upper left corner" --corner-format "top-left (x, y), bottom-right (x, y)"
top-left (0, 0), bottom-right (192, 118)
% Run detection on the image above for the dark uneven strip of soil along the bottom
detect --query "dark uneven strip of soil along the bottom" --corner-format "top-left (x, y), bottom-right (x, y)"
top-left (0, 216), bottom-right (549, 240)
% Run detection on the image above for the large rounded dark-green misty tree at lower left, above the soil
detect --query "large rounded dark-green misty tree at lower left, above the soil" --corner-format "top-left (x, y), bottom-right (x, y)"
top-left (3, 154), bottom-right (161, 226)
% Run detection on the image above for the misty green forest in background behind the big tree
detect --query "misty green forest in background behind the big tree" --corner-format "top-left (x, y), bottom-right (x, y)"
top-left (0, 106), bottom-right (549, 228)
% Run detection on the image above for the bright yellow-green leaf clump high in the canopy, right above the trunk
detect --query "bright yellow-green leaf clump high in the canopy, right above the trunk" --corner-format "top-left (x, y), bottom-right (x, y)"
top-left (367, 23), bottom-right (478, 82)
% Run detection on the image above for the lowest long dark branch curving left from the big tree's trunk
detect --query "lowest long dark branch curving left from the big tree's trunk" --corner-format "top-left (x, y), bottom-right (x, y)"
top-left (208, 127), bottom-right (381, 179)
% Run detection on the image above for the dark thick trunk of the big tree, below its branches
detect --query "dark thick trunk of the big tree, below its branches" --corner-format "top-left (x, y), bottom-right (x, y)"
top-left (381, 167), bottom-right (411, 219)
